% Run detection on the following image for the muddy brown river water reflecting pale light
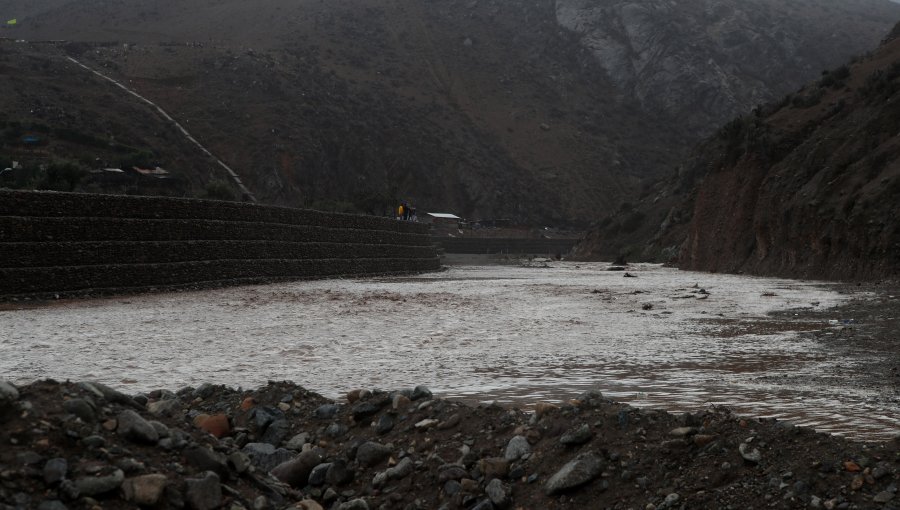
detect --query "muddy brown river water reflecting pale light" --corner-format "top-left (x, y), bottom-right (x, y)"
top-left (0, 262), bottom-right (900, 439)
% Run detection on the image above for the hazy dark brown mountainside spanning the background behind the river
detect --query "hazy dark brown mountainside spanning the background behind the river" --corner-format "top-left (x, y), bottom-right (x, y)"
top-left (0, 0), bottom-right (900, 225)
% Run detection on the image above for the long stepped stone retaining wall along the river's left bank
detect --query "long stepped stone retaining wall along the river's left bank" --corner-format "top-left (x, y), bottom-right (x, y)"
top-left (0, 190), bottom-right (440, 299)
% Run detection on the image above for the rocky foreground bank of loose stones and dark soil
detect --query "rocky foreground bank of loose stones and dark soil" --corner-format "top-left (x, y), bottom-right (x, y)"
top-left (0, 381), bottom-right (900, 510)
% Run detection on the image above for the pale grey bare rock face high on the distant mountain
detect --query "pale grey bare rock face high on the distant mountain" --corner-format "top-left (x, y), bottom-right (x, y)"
top-left (556, 0), bottom-right (900, 135)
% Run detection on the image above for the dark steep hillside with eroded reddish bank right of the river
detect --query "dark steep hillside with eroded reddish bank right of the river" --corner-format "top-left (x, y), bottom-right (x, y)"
top-left (580, 22), bottom-right (900, 279)
